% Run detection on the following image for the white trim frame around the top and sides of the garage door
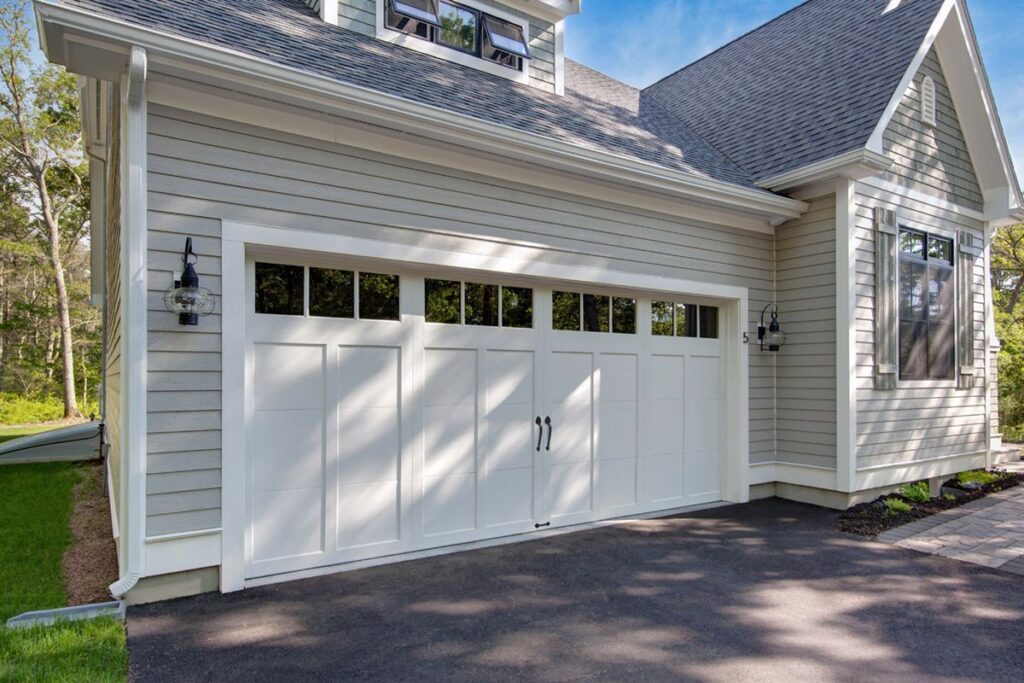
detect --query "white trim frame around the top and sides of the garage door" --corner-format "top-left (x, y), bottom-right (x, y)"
top-left (221, 221), bottom-right (749, 592)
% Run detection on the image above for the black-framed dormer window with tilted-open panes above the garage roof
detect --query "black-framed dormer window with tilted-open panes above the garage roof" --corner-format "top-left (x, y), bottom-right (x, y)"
top-left (385, 0), bottom-right (529, 77)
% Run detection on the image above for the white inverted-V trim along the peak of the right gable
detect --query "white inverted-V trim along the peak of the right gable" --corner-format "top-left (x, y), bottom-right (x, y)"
top-left (867, 0), bottom-right (1024, 221)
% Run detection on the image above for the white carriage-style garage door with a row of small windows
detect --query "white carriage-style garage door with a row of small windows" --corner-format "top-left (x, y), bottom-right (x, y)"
top-left (246, 258), bottom-right (725, 579)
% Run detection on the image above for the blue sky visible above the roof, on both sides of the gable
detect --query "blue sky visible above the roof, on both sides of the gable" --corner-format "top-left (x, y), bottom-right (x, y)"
top-left (565, 0), bottom-right (1024, 175)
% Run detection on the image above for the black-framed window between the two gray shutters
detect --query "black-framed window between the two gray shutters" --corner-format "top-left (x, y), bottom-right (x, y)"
top-left (899, 227), bottom-right (956, 380)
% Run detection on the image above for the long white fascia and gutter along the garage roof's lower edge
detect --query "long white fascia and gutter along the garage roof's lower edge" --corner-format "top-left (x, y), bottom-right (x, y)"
top-left (36, 0), bottom-right (807, 220)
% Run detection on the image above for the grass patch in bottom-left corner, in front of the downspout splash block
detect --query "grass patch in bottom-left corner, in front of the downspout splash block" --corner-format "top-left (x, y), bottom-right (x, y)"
top-left (0, 618), bottom-right (128, 683)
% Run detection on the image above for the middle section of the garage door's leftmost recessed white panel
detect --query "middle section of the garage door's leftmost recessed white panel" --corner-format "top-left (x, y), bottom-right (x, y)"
top-left (253, 411), bottom-right (324, 493)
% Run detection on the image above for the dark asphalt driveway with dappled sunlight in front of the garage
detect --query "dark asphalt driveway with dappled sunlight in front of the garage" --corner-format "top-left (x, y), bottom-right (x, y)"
top-left (128, 500), bottom-right (1024, 683)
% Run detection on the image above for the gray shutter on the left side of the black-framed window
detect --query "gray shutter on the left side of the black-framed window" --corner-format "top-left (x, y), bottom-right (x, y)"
top-left (874, 207), bottom-right (899, 390)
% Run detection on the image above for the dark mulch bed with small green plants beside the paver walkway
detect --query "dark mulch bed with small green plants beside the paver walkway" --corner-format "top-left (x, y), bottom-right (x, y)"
top-left (839, 470), bottom-right (1024, 537)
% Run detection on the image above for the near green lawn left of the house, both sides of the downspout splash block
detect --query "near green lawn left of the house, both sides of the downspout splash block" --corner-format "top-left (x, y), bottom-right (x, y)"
top-left (0, 463), bottom-right (128, 681)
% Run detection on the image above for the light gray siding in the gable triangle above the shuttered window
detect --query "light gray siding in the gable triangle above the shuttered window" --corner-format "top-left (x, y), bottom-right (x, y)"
top-left (883, 49), bottom-right (983, 211)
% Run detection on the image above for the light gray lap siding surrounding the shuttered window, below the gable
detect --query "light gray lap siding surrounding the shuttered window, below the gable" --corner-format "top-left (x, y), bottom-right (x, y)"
top-left (856, 184), bottom-right (988, 469)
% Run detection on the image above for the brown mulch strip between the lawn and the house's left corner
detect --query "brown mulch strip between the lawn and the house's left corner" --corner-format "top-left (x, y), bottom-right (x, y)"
top-left (61, 461), bottom-right (118, 605)
